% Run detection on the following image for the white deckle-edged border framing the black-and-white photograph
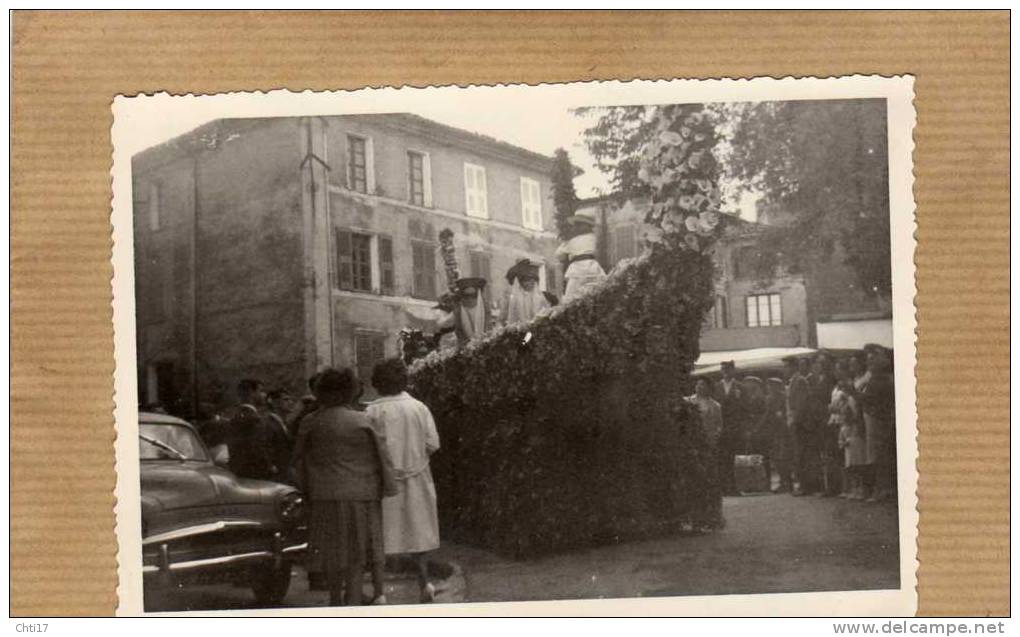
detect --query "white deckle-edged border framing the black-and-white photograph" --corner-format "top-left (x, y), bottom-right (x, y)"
top-left (111, 75), bottom-right (918, 617)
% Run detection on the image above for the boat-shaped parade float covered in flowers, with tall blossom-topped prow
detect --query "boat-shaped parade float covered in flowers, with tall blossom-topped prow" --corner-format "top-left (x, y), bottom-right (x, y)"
top-left (405, 105), bottom-right (722, 558)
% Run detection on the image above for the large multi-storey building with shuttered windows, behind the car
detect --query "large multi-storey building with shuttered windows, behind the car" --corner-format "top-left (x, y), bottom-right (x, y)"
top-left (133, 113), bottom-right (560, 412)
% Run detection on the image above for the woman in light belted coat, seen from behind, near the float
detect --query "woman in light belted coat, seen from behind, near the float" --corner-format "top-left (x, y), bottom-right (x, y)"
top-left (367, 359), bottom-right (440, 602)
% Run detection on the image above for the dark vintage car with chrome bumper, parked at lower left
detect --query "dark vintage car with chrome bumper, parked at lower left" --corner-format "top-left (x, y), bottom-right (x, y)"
top-left (139, 413), bottom-right (307, 606)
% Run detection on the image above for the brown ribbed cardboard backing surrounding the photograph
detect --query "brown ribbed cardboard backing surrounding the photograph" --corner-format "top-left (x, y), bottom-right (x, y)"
top-left (10, 11), bottom-right (1010, 616)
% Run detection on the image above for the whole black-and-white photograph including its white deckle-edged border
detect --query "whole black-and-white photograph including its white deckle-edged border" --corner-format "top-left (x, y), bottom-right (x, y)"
top-left (113, 76), bottom-right (916, 616)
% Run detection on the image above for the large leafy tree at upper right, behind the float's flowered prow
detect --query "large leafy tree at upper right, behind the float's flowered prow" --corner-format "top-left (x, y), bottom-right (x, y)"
top-left (722, 100), bottom-right (891, 299)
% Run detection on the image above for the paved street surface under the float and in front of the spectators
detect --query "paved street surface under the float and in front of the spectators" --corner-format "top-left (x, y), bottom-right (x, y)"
top-left (147, 494), bottom-right (899, 611)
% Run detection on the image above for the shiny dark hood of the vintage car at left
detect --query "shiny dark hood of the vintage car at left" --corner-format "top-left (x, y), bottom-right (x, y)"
top-left (141, 461), bottom-right (295, 511)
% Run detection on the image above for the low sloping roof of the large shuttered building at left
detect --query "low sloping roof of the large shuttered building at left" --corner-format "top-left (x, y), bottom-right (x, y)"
top-left (132, 113), bottom-right (554, 172)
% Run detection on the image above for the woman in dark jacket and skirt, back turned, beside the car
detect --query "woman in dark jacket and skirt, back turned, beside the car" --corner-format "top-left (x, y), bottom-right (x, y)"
top-left (295, 369), bottom-right (397, 605)
